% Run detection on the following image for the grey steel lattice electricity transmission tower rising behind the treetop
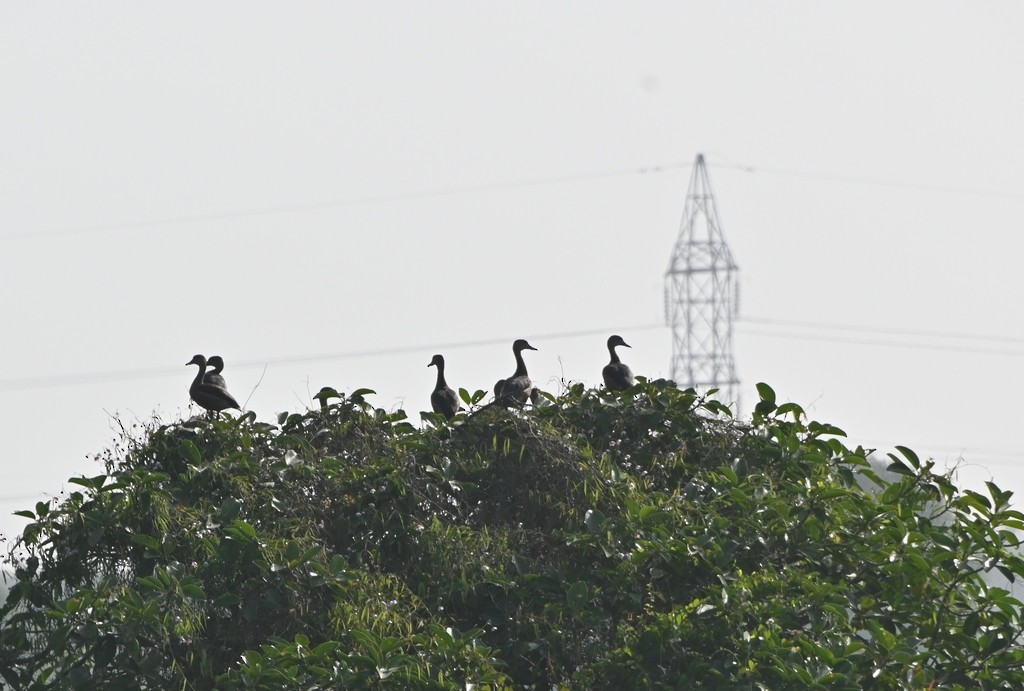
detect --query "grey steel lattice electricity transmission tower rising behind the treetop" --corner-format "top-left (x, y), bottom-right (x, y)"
top-left (665, 154), bottom-right (739, 404)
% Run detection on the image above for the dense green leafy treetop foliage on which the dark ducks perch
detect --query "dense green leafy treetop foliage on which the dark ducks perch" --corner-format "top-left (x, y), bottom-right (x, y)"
top-left (0, 381), bottom-right (1024, 690)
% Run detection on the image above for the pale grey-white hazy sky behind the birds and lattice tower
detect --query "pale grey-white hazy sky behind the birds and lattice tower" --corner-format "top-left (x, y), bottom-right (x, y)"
top-left (0, 0), bottom-right (1024, 535)
